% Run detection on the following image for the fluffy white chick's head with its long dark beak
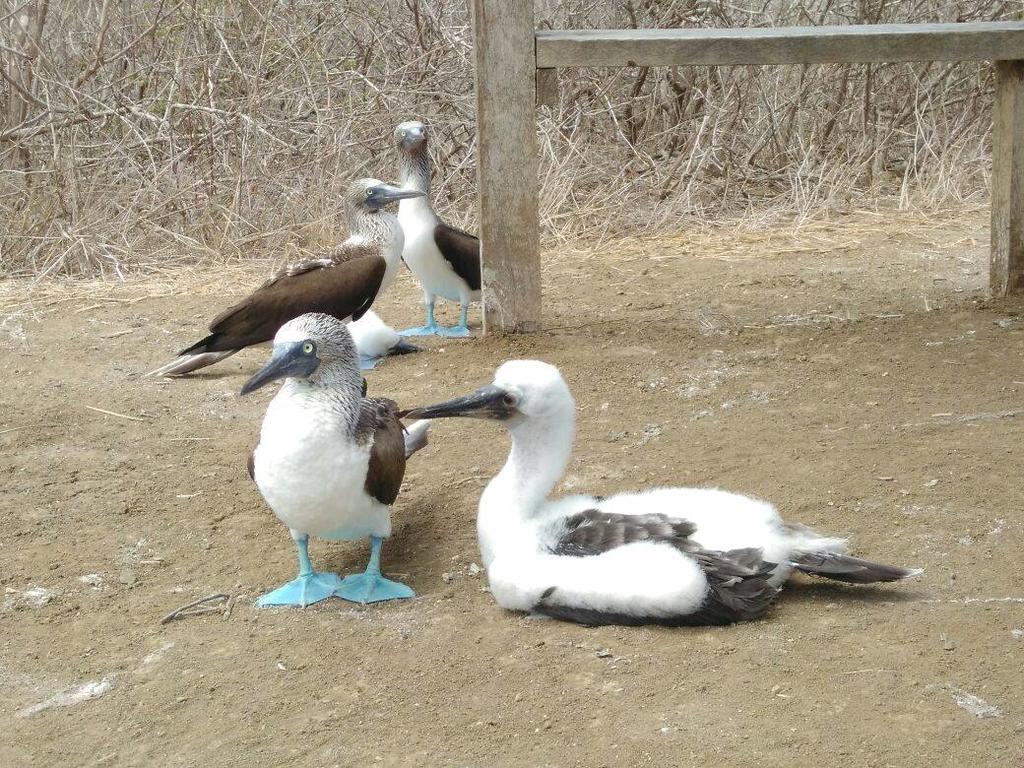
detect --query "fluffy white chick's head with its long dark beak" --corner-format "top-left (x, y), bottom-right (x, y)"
top-left (404, 360), bottom-right (575, 427)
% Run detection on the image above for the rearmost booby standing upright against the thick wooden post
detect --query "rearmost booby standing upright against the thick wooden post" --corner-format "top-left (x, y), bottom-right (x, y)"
top-left (394, 121), bottom-right (480, 336)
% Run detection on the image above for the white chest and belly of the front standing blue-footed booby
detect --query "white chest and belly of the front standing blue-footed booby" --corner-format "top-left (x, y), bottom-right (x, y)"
top-left (253, 397), bottom-right (391, 540)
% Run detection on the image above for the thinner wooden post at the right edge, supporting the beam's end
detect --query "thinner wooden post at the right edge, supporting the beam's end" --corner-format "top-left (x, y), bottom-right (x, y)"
top-left (989, 60), bottom-right (1024, 296)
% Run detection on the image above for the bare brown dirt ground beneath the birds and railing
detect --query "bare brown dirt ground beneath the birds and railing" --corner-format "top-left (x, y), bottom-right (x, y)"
top-left (0, 205), bottom-right (1024, 768)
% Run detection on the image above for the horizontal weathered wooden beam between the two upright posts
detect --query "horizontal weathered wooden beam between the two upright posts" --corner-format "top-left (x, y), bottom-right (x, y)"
top-left (537, 22), bottom-right (1024, 68)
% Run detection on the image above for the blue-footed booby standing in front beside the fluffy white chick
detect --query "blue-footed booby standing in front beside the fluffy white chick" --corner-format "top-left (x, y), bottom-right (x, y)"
top-left (242, 313), bottom-right (428, 606)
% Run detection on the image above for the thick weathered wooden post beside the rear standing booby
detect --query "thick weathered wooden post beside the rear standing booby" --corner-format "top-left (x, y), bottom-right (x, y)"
top-left (473, 0), bottom-right (541, 333)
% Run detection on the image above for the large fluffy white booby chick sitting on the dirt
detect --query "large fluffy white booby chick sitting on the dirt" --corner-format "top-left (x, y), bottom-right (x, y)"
top-left (407, 360), bottom-right (921, 626)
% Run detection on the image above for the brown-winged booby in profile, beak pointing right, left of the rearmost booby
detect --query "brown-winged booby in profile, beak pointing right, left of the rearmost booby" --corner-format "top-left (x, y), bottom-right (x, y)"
top-left (147, 178), bottom-right (422, 376)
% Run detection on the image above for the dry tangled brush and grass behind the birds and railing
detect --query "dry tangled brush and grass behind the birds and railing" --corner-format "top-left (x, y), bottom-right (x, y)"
top-left (0, 0), bottom-right (1019, 278)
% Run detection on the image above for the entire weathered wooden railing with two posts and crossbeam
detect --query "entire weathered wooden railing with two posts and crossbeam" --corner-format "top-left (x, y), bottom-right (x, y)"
top-left (473, 0), bottom-right (1024, 333)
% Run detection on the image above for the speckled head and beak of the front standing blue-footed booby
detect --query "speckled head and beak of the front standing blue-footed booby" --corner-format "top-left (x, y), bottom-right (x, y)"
top-left (242, 312), bottom-right (361, 394)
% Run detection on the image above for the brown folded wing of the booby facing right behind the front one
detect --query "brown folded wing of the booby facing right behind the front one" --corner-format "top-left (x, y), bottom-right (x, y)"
top-left (191, 251), bottom-right (387, 353)
